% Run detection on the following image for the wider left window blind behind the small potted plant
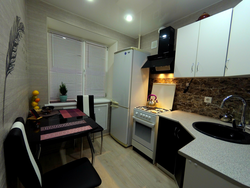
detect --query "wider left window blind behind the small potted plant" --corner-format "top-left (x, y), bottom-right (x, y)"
top-left (50, 34), bottom-right (83, 100)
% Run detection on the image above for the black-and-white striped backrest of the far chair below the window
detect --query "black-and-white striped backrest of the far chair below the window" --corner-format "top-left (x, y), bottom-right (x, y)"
top-left (77, 95), bottom-right (95, 121)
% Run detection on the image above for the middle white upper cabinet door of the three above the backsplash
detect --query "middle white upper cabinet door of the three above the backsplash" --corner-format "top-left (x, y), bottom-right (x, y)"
top-left (195, 9), bottom-right (232, 77)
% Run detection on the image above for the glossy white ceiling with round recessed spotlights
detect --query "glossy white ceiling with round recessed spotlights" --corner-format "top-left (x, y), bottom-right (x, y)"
top-left (41, 0), bottom-right (221, 38)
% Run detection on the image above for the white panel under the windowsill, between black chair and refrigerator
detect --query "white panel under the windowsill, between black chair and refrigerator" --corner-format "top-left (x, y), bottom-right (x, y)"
top-left (94, 104), bottom-right (109, 130)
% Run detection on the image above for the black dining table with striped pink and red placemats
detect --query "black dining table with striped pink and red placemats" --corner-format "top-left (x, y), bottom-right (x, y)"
top-left (25, 109), bottom-right (100, 164)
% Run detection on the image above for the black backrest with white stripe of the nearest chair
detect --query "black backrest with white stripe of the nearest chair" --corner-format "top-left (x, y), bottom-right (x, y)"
top-left (4, 118), bottom-right (42, 188)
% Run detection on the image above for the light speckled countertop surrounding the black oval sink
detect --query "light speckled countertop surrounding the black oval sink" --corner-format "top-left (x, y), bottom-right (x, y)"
top-left (160, 110), bottom-right (250, 187)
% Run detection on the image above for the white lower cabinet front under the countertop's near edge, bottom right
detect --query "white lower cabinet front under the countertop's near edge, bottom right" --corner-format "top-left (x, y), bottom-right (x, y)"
top-left (183, 159), bottom-right (240, 188)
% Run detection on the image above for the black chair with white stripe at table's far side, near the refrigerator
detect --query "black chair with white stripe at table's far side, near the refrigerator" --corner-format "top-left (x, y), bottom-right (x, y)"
top-left (77, 95), bottom-right (103, 154)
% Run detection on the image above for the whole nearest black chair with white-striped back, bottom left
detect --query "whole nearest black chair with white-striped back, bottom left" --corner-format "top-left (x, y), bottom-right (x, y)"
top-left (4, 118), bottom-right (102, 188)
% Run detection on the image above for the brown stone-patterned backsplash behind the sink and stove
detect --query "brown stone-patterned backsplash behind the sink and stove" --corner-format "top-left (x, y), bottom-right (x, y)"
top-left (149, 75), bottom-right (250, 125)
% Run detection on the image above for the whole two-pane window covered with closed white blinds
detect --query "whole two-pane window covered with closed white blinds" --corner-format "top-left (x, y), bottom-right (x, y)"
top-left (49, 34), bottom-right (106, 101)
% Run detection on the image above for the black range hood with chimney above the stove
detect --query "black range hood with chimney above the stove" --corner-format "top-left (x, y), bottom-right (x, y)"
top-left (142, 26), bottom-right (175, 74)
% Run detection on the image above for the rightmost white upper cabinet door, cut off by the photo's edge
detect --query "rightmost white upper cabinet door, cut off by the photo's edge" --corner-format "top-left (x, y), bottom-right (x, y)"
top-left (225, 0), bottom-right (250, 76)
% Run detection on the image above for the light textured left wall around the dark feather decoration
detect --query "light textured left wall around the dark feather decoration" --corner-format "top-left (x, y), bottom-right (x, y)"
top-left (0, 0), bottom-right (29, 188)
